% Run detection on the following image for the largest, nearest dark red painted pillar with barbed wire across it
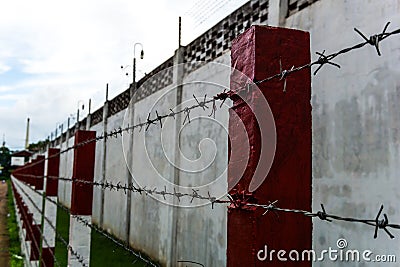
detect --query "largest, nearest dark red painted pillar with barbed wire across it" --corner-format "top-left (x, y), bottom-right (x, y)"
top-left (227, 26), bottom-right (312, 267)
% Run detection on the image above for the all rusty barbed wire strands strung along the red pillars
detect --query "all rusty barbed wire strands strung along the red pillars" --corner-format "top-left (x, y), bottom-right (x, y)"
top-left (10, 22), bottom-right (400, 266)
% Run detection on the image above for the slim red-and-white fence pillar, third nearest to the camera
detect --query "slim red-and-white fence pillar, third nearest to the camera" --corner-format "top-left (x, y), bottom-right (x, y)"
top-left (42, 148), bottom-right (60, 267)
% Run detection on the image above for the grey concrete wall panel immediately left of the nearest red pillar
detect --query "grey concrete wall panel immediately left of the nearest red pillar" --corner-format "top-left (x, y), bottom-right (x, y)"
top-left (172, 53), bottom-right (231, 266)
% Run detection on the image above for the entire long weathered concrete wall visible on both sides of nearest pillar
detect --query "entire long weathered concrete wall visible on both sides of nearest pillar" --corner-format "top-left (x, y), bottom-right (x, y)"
top-left (50, 0), bottom-right (400, 266)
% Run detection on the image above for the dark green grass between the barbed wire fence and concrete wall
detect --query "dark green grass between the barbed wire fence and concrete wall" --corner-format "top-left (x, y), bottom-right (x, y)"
top-left (55, 205), bottom-right (156, 267)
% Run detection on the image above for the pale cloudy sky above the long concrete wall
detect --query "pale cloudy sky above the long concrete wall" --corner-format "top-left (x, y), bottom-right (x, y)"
top-left (0, 0), bottom-right (246, 149)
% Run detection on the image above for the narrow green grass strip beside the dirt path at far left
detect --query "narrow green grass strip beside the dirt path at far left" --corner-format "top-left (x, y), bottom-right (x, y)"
top-left (4, 176), bottom-right (24, 267)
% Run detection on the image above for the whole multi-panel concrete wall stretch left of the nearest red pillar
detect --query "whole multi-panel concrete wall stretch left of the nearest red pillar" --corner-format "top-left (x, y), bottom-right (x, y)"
top-left (55, 53), bottom-right (230, 266)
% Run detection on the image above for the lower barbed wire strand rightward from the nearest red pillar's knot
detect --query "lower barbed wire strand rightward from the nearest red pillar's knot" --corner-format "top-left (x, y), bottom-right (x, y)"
top-left (245, 200), bottom-right (400, 239)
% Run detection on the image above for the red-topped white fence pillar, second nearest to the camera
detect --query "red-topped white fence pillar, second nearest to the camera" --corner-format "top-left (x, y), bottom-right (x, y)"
top-left (68, 130), bottom-right (96, 266)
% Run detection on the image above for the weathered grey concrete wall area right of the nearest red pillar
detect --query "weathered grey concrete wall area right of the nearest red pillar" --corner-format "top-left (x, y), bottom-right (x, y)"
top-left (285, 0), bottom-right (400, 266)
